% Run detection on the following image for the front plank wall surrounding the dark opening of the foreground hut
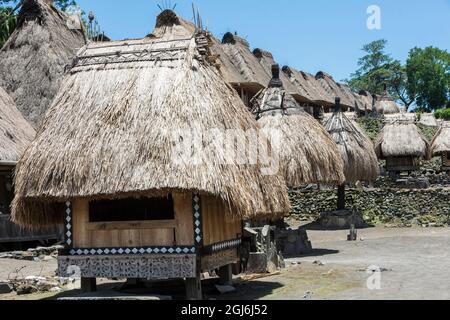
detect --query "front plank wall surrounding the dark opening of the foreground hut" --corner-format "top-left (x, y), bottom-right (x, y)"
top-left (72, 194), bottom-right (194, 248)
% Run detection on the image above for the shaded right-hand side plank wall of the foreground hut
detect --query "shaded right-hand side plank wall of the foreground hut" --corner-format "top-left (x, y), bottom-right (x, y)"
top-left (202, 196), bottom-right (242, 246)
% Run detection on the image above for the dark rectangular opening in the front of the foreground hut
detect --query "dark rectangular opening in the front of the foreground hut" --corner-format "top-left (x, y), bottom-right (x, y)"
top-left (89, 195), bottom-right (175, 222)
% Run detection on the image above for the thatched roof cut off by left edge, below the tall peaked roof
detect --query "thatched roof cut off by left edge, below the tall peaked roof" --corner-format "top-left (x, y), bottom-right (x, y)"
top-left (0, 87), bottom-right (36, 163)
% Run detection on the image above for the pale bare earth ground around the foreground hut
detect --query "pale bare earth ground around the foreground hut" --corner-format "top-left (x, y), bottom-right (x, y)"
top-left (0, 227), bottom-right (450, 300)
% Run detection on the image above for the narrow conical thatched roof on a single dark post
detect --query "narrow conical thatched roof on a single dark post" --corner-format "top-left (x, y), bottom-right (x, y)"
top-left (325, 101), bottom-right (379, 182)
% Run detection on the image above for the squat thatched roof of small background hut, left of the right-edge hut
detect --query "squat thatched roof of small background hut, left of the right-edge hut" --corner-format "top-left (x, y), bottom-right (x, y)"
top-left (375, 118), bottom-right (428, 159)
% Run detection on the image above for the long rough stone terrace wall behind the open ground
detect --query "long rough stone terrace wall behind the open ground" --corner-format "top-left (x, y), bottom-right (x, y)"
top-left (289, 187), bottom-right (450, 226)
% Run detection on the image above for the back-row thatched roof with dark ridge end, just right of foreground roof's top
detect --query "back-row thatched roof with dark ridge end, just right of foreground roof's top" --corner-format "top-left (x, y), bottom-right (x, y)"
top-left (221, 32), bottom-right (270, 91)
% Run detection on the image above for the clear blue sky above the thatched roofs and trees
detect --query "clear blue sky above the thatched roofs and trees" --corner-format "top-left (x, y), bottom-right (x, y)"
top-left (78, 0), bottom-right (450, 80)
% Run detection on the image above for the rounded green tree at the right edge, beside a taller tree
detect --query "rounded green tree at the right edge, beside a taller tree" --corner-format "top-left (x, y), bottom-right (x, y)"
top-left (406, 47), bottom-right (450, 112)
